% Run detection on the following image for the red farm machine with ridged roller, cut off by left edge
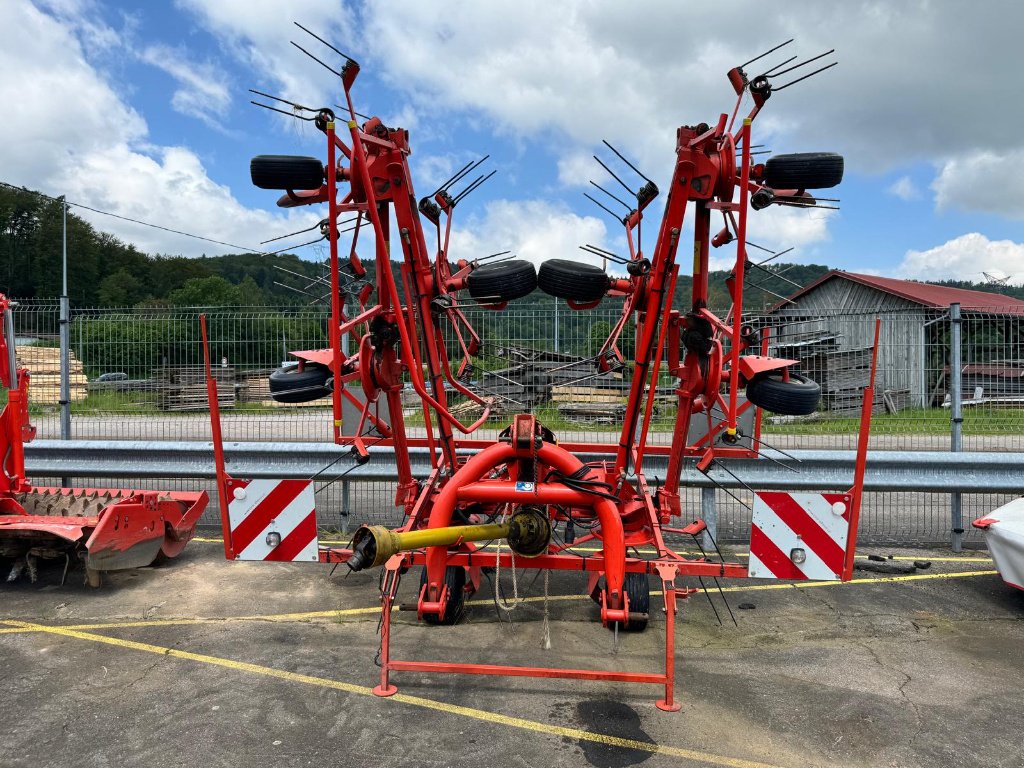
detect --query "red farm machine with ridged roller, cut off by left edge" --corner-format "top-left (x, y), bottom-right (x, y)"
top-left (0, 294), bottom-right (209, 587)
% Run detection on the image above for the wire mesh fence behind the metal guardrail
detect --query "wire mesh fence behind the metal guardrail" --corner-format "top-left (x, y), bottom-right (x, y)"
top-left (9, 299), bottom-right (1024, 544)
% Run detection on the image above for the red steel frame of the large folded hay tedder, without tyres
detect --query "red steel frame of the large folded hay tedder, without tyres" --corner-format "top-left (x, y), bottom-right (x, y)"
top-left (216, 51), bottom-right (873, 711)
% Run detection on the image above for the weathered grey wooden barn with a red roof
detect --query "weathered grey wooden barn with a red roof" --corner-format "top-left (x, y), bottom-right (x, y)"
top-left (763, 269), bottom-right (1024, 412)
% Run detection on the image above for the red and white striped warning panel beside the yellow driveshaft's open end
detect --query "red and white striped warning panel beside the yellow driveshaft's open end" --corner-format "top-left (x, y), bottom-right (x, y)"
top-left (227, 477), bottom-right (319, 562)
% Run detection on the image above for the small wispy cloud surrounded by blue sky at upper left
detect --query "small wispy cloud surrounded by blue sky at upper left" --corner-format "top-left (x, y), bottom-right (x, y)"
top-left (139, 45), bottom-right (231, 130)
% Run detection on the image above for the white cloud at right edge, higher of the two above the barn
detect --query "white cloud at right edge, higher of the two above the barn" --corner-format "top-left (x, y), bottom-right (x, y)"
top-left (932, 148), bottom-right (1024, 219)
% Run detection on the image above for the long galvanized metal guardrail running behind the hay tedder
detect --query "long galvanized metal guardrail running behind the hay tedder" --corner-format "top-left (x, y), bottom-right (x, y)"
top-left (26, 440), bottom-right (1024, 494)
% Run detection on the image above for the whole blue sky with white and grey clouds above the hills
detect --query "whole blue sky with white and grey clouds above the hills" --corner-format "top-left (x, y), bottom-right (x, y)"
top-left (0, 0), bottom-right (1024, 283)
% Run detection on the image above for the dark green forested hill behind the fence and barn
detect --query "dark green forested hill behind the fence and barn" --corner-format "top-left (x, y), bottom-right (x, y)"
top-left (0, 186), bottom-right (1024, 309)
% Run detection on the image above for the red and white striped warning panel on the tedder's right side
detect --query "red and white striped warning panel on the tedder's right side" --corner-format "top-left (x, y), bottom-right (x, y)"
top-left (748, 492), bottom-right (852, 582)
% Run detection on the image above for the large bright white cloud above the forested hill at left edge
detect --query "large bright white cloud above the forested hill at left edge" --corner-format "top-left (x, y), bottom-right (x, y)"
top-left (0, 3), bottom-right (316, 256)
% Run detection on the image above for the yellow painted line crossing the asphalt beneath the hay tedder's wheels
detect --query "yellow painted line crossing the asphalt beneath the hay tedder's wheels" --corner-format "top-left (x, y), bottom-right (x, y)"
top-left (0, 570), bottom-right (998, 635)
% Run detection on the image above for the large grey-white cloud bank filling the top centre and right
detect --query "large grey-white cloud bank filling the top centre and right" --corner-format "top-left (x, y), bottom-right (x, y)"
top-left (356, 0), bottom-right (1024, 170)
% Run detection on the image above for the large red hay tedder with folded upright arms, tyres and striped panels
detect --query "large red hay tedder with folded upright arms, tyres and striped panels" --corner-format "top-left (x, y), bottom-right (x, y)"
top-left (203, 28), bottom-right (873, 711)
